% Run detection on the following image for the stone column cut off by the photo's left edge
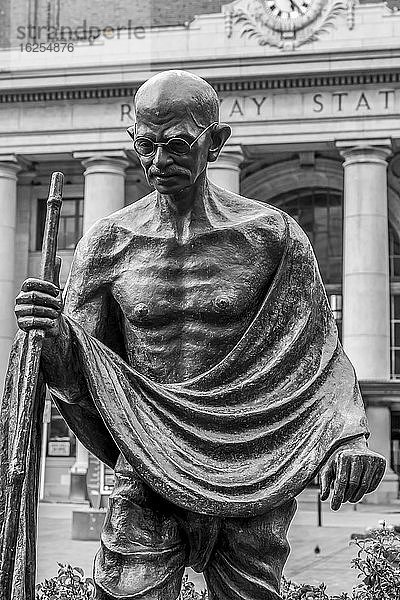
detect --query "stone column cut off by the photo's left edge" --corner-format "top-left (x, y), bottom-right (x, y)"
top-left (0, 155), bottom-right (20, 392)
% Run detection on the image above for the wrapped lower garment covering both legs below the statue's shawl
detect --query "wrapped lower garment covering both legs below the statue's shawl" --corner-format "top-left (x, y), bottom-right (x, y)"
top-left (94, 456), bottom-right (296, 600)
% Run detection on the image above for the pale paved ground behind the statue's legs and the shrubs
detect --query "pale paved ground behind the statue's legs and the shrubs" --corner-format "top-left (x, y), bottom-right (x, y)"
top-left (38, 494), bottom-right (400, 594)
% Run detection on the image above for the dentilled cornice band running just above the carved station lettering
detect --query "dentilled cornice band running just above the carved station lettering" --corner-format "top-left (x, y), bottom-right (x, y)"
top-left (0, 71), bottom-right (400, 104)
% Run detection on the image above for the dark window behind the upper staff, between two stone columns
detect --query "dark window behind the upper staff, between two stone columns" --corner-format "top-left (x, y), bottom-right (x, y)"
top-left (36, 198), bottom-right (83, 250)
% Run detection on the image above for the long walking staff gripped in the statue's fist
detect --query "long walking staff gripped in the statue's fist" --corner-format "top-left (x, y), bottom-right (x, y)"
top-left (0, 172), bottom-right (64, 600)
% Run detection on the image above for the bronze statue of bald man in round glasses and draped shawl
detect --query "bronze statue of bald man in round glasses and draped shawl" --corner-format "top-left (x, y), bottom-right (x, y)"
top-left (16, 71), bottom-right (385, 600)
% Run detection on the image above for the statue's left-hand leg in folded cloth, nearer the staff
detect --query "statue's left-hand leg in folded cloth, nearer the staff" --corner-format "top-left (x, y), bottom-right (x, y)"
top-left (94, 459), bottom-right (187, 600)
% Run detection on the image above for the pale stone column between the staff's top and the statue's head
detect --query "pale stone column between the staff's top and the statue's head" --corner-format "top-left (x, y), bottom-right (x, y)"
top-left (70, 151), bottom-right (129, 502)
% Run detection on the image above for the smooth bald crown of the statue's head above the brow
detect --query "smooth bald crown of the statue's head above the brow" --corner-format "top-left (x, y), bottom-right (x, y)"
top-left (134, 70), bottom-right (219, 127)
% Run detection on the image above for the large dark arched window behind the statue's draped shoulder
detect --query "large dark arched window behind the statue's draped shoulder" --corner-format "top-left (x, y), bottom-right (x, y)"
top-left (271, 187), bottom-right (343, 286)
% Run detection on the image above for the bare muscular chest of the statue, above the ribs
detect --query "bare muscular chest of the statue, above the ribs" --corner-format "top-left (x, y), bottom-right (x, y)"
top-left (111, 237), bottom-right (276, 328)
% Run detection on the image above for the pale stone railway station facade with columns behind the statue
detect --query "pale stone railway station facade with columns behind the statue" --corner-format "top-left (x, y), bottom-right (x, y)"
top-left (0, 0), bottom-right (400, 501)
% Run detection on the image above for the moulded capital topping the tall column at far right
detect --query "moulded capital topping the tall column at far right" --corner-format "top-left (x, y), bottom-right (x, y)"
top-left (336, 138), bottom-right (392, 167)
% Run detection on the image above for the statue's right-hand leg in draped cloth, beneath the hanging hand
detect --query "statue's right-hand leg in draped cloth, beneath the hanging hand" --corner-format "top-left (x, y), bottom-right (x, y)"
top-left (204, 500), bottom-right (296, 600)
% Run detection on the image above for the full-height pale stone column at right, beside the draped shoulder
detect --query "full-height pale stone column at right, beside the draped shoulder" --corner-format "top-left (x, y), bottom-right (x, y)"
top-left (337, 139), bottom-right (398, 502)
